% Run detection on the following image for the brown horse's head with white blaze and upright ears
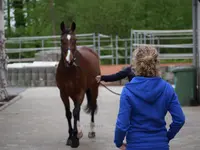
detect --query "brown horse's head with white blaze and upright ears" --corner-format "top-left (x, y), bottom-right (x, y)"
top-left (60, 21), bottom-right (76, 67)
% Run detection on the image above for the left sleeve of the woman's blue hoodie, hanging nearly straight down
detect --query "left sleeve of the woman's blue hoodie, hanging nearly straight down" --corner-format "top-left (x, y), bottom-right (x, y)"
top-left (114, 88), bottom-right (131, 148)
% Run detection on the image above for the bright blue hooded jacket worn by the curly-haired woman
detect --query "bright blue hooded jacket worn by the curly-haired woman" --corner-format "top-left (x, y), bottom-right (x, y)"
top-left (114, 76), bottom-right (185, 150)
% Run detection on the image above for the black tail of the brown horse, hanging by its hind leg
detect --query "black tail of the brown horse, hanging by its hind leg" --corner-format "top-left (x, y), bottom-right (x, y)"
top-left (84, 89), bottom-right (98, 114)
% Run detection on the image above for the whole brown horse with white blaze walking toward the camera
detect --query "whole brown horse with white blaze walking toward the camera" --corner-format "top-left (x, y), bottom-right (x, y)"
top-left (56, 21), bottom-right (101, 148)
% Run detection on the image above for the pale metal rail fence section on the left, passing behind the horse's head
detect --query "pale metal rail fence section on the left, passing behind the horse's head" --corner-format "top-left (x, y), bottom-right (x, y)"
top-left (6, 33), bottom-right (96, 62)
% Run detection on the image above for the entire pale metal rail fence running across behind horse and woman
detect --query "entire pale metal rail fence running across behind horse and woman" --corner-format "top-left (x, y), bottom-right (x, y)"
top-left (6, 30), bottom-right (193, 64)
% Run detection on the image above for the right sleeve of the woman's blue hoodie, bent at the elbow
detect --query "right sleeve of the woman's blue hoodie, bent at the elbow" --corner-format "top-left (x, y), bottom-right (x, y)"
top-left (167, 88), bottom-right (185, 141)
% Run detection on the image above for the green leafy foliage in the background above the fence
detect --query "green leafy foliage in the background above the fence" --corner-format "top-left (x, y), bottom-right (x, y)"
top-left (4, 0), bottom-right (192, 37)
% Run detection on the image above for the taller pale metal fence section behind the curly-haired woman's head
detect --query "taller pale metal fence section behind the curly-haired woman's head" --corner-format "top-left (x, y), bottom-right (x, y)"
top-left (130, 30), bottom-right (195, 63)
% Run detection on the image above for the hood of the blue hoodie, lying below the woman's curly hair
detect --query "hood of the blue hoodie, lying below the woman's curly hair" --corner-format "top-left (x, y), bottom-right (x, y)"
top-left (125, 76), bottom-right (166, 103)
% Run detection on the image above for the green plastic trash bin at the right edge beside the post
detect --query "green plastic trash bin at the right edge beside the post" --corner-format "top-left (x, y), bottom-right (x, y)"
top-left (172, 66), bottom-right (197, 106)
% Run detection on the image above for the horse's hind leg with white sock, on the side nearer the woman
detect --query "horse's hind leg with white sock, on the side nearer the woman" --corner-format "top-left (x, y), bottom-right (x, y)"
top-left (86, 88), bottom-right (98, 138)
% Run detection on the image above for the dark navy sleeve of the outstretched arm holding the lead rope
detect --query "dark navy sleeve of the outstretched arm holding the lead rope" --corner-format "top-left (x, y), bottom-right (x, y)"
top-left (101, 67), bottom-right (131, 82)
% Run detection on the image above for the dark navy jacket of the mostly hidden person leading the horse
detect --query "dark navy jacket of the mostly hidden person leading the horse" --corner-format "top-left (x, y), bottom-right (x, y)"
top-left (101, 66), bottom-right (135, 82)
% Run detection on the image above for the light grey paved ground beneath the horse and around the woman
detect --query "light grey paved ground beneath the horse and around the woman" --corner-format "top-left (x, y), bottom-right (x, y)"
top-left (0, 87), bottom-right (200, 150)
